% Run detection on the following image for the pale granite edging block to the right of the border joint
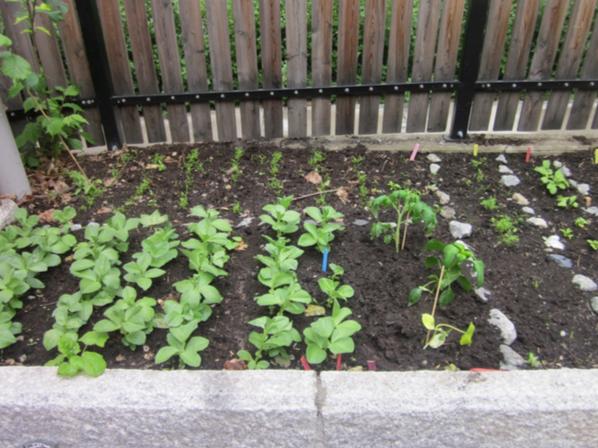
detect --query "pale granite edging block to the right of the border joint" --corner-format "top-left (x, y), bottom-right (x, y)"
top-left (320, 369), bottom-right (598, 448)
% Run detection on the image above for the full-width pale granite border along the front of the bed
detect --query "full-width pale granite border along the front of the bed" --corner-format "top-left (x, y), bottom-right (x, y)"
top-left (0, 367), bottom-right (598, 448)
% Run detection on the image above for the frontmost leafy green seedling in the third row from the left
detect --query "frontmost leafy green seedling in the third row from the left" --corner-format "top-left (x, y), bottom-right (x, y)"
top-left (93, 286), bottom-right (156, 349)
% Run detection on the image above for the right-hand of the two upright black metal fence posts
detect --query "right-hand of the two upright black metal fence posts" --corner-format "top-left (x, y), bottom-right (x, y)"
top-left (451, 0), bottom-right (490, 140)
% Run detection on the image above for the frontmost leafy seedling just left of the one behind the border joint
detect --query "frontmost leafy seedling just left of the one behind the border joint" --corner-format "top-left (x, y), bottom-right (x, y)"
top-left (237, 316), bottom-right (301, 369)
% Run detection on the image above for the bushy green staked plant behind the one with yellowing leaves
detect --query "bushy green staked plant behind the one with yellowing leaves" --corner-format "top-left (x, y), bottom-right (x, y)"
top-left (370, 183), bottom-right (437, 253)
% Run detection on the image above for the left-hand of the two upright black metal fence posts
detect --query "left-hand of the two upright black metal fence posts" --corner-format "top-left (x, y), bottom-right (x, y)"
top-left (76, 0), bottom-right (122, 149)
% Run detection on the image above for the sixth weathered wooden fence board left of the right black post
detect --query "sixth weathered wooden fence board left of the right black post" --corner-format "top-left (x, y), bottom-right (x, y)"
top-left (311, 0), bottom-right (332, 136)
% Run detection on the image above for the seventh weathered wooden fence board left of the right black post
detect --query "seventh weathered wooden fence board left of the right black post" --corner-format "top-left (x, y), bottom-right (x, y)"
top-left (286, 0), bottom-right (307, 137)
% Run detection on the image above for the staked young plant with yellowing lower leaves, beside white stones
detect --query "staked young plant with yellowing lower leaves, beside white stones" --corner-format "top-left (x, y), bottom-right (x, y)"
top-left (409, 240), bottom-right (484, 348)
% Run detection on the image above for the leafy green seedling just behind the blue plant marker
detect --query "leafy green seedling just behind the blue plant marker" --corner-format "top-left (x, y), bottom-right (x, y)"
top-left (297, 205), bottom-right (345, 253)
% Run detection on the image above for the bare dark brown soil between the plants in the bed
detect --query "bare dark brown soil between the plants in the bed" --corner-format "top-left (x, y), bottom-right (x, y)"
top-left (0, 144), bottom-right (598, 370)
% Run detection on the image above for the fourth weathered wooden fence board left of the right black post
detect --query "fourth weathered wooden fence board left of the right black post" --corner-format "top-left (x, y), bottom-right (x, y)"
top-left (359, 0), bottom-right (386, 134)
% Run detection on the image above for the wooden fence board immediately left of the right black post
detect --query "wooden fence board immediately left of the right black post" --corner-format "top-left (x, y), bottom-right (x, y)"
top-left (428, 0), bottom-right (465, 132)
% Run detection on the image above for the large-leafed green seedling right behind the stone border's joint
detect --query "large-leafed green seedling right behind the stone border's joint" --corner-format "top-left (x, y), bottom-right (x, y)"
top-left (303, 305), bottom-right (361, 364)
